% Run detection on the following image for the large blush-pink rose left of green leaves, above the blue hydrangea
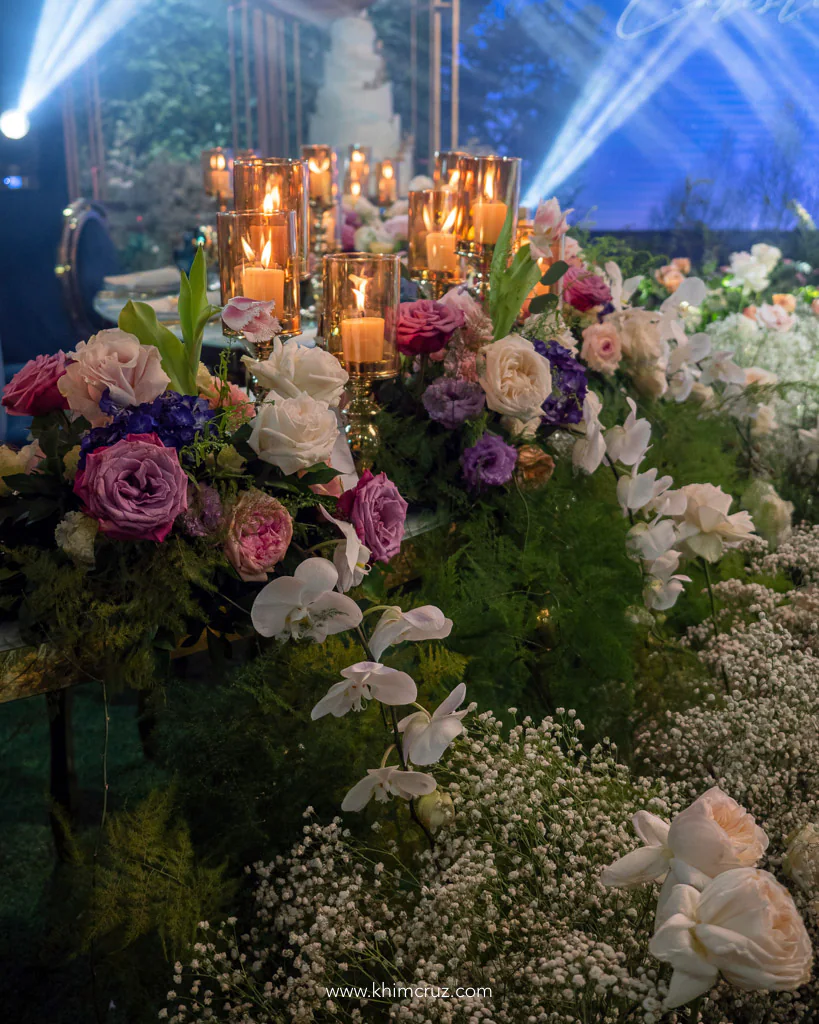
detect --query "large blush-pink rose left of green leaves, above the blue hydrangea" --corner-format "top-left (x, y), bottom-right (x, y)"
top-left (57, 328), bottom-right (171, 427)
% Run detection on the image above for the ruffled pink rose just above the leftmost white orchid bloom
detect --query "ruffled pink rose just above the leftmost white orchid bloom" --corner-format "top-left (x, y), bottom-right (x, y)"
top-left (224, 490), bottom-right (293, 583)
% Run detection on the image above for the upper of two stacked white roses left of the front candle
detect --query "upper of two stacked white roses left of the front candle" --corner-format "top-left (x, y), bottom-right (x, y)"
top-left (242, 338), bottom-right (349, 409)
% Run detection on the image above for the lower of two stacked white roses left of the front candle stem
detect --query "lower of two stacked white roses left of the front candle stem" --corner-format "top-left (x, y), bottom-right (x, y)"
top-left (248, 393), bottom-right (339, 474)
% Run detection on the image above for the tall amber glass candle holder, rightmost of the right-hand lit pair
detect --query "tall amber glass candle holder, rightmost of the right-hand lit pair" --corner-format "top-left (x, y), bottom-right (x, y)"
top-left (458, 156), bottom-right (520, 297)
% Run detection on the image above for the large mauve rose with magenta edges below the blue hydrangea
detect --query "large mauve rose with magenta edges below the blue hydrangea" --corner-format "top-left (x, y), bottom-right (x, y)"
top-left (74, 434), bottom-right (187, 541)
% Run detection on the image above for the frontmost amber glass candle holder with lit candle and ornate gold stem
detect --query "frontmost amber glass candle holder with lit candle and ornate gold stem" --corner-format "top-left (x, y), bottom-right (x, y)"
top-left (324, 253), bottom-right (401, 467)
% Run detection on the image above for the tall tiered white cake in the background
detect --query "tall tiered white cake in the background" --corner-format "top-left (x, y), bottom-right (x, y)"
top-left (310, 13), bottom-right (401, 160)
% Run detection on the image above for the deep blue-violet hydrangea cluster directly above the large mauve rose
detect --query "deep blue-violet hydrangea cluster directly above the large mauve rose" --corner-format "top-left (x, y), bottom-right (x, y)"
top-left (78, 391), bottom-right (216, 469)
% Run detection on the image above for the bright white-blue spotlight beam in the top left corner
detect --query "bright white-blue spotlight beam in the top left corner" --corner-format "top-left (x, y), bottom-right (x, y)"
top-left (17, 0), bottom-right (144, 114)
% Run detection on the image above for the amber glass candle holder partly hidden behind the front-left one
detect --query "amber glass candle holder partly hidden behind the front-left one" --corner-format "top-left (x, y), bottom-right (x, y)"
top-left (233, 157), bottom-right (310, 281)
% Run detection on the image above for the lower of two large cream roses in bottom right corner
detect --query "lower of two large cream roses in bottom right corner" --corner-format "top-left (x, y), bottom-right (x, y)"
top-left (649, 867), bottom-right (813, 1009)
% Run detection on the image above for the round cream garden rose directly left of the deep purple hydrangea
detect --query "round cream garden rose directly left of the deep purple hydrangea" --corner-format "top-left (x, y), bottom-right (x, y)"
top-left (480, 334), bottom-right (552, 420)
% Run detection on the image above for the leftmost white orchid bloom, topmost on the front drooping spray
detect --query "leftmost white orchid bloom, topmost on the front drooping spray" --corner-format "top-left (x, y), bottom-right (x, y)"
top-left (251, 558), bottom-right (361, 643)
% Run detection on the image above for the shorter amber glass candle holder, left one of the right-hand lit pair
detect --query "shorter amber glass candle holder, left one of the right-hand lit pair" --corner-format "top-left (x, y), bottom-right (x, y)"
top-left (408, 188), bottom-right (466, 299)
